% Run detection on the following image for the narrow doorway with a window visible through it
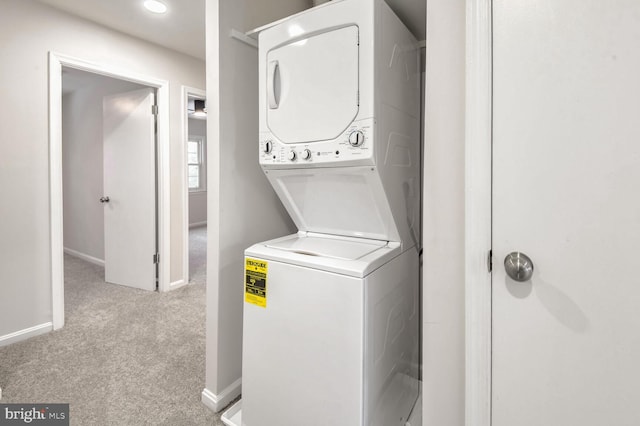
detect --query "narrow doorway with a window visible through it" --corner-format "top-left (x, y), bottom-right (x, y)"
top-left (183, 87), bottom-right (207, 284)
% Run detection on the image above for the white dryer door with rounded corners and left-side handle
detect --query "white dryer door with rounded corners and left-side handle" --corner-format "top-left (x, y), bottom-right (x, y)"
top-left (263, 25), bottom-right (358, 143)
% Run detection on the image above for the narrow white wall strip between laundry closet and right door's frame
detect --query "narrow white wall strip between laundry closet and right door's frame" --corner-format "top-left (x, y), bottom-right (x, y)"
top-left (422, 0), bottom-right (465, 426)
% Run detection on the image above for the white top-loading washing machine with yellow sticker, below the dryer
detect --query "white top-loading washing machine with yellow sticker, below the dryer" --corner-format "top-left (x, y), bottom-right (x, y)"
top-left (242, 233), bottom-right (419, 426)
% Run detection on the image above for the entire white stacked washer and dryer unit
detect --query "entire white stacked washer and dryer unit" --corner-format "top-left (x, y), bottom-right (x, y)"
top-left (225, 0), bottom-right (421, 426)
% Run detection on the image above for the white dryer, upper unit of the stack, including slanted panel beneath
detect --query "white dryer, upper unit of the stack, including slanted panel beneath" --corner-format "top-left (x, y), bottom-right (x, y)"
top-left (258, 0), bottom-right (420, 251)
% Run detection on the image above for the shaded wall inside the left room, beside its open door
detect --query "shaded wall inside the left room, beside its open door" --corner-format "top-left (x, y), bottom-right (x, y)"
top-left (62, 72), bottom-right (142, 261)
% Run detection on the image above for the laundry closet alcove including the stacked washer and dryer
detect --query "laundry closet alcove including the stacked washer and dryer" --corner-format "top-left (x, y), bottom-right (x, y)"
top-left (203, 0), bottom-right (423, 426)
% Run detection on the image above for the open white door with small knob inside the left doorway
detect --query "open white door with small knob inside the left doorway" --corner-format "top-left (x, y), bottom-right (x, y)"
top-left (103, 89), bottom-right (156, 290)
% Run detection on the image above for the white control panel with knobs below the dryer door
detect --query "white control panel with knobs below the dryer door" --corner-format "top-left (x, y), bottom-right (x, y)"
top-left (259, 119), bottom-right (374, 168)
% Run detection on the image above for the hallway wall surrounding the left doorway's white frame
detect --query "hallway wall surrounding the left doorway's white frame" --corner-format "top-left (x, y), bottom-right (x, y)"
top-left (0, 0), bottom-right (204, 337)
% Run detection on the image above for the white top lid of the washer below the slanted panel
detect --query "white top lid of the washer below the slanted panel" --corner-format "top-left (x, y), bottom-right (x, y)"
top-left (265, 235), bottom-right (387, 260)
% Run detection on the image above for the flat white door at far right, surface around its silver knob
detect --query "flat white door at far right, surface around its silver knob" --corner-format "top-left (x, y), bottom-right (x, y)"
top-left (492, 0), bottom-right (640, 426)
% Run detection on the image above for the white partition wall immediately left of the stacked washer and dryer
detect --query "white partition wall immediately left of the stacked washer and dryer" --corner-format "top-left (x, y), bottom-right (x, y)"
top-left (203, 0), bottom-right (307, 410)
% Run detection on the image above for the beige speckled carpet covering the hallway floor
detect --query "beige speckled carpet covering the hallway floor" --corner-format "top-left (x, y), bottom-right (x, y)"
top-left (0, 228), bottom-right (228, 426)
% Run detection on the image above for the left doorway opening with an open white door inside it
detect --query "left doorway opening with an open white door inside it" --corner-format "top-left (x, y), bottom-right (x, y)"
top-left (62, 67), bottom-right (157, 290)
